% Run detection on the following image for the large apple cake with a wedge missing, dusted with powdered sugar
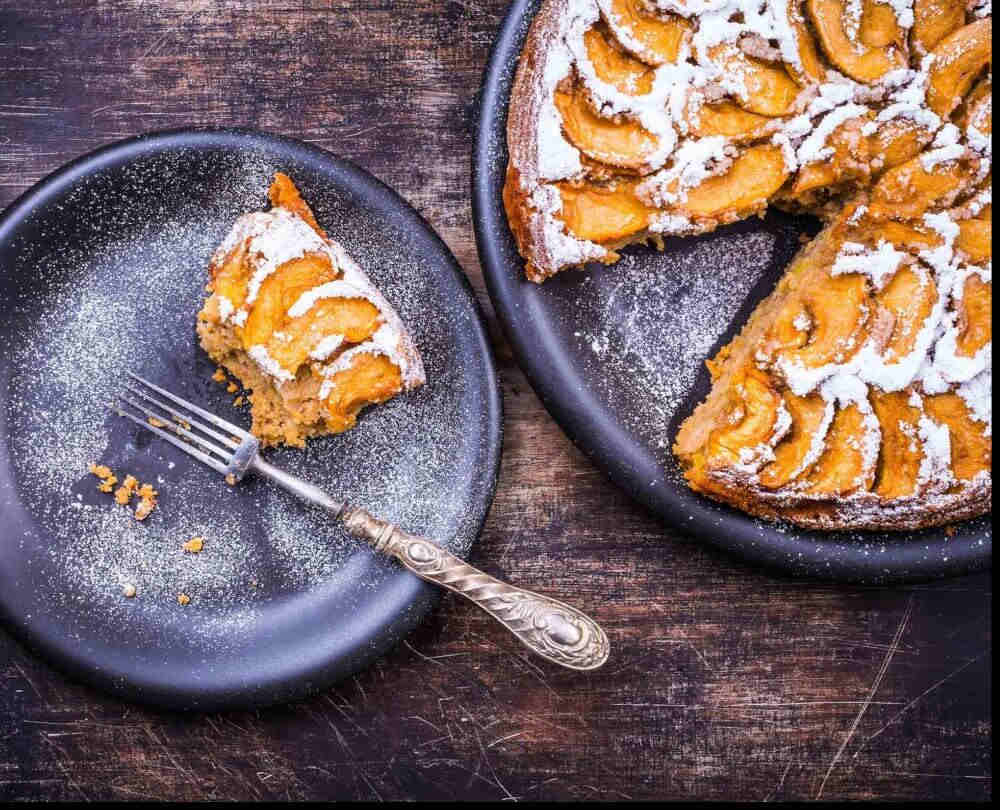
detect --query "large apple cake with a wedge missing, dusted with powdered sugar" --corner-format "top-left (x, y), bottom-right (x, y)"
top-left (503, 0), bottom-right (992, 529)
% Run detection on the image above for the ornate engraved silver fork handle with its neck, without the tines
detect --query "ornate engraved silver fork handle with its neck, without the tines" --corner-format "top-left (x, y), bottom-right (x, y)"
top-left (250, 456), bottom-right (609, 670)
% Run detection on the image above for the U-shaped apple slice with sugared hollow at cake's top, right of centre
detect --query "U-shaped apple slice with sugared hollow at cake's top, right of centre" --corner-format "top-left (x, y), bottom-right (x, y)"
top-left (806, 0), bottom-right (907, 84)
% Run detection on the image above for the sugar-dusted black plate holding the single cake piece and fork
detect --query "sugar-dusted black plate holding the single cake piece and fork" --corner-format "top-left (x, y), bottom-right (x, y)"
top-left (0, 130), bottom-right (501, 709)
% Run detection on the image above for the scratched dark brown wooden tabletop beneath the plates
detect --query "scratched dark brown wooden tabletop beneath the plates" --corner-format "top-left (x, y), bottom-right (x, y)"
top-left (0, 0), bottom-right (992, 800)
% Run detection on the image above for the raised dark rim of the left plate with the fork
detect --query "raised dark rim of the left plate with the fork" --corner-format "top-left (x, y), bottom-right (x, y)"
top-left (0, 125), bottom-right (504, 711)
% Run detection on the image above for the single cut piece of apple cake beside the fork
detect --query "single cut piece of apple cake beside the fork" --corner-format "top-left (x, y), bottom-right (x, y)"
top-left (197, 173), bottom-right (424, 447)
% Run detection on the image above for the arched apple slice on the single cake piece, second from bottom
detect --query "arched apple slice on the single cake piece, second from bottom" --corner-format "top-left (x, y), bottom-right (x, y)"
top-left (268, 298), bottom-right (381, 373)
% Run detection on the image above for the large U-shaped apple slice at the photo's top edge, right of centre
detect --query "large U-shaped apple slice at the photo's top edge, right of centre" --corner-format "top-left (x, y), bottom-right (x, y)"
top-left (806, 0), bottom-right (906, 84)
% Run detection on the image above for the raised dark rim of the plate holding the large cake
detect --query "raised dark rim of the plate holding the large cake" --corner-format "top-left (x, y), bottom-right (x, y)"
top-left (471, 0), bottom-right (992, 584)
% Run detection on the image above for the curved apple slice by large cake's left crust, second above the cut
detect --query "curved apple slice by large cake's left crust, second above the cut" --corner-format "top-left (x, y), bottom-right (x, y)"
top-left (556, 91), bottom-right (656, 169)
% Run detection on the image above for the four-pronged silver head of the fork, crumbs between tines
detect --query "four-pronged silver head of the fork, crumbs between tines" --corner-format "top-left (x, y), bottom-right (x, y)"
top-left (108, 371), bottom-right (255, 473)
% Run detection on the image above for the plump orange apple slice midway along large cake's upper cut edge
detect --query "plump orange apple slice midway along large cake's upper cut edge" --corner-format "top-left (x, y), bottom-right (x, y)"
top-left (679, 144), bottom-right (788, 218)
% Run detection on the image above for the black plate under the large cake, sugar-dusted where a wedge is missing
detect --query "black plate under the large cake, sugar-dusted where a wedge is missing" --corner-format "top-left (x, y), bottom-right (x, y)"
top-left (473, 0), bottom-right (992, 582)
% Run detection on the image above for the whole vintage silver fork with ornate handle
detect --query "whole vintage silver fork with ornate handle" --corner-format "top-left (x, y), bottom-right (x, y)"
top-left (110, 372), bottom-right (609, 670)
